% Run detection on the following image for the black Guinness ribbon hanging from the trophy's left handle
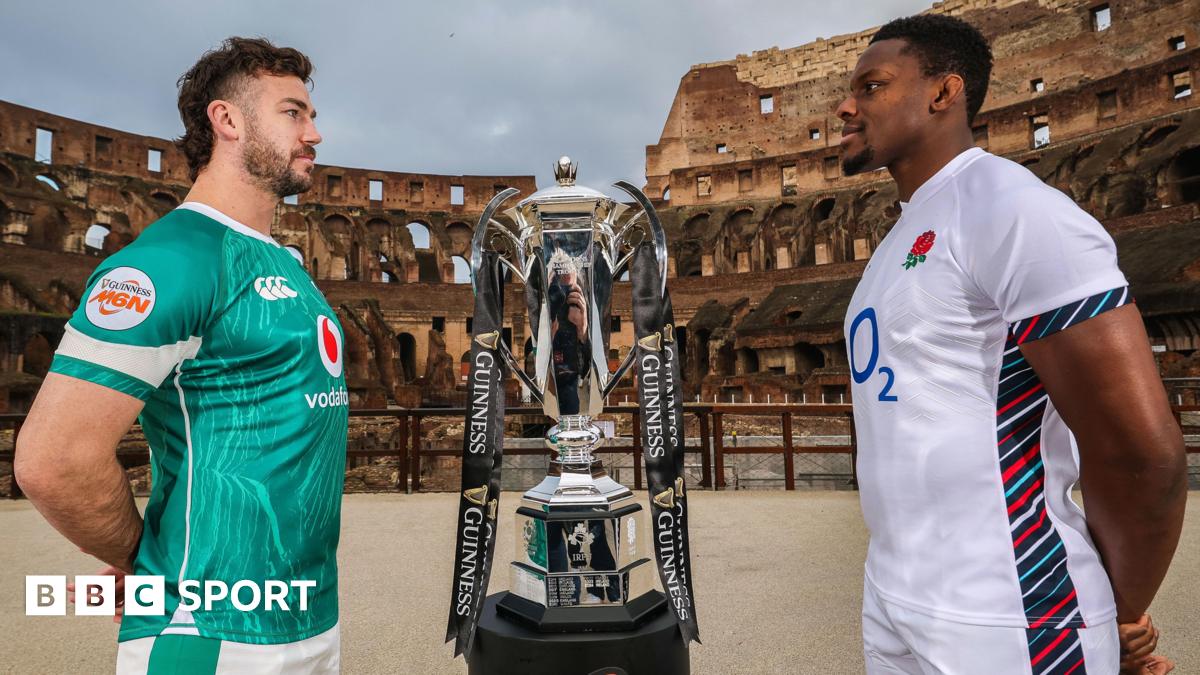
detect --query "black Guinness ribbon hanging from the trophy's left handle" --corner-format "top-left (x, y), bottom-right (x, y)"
top-left (446, 251), bottom-right (506, 658)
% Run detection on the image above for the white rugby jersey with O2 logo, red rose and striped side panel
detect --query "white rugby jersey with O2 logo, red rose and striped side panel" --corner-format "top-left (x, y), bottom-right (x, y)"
top-left (845, 148), bottom-right (1132, 628)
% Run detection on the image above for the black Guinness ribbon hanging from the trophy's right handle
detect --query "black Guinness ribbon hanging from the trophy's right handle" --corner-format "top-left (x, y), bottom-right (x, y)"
top-left (630, 241), bottom-right (700, 644)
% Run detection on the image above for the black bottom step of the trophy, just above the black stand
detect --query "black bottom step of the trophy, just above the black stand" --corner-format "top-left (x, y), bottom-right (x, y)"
top-left (496, 590), bottom-right (667, 633)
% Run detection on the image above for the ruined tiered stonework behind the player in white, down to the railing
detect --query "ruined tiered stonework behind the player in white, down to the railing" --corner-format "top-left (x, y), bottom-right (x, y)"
top-left (646, 0), bottom-right (1200, 402)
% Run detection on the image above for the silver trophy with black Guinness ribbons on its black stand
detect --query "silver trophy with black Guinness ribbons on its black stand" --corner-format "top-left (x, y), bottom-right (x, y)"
top-left (446, 157), bottom-right (698, 675)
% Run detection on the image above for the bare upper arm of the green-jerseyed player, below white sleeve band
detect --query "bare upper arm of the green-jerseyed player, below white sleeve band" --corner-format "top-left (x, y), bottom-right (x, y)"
top-left (20, 372), bottom-right (144, 464)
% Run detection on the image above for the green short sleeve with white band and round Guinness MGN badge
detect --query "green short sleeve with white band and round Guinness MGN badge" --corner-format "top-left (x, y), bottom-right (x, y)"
top-left (50, 224), bottom-right (220, 400)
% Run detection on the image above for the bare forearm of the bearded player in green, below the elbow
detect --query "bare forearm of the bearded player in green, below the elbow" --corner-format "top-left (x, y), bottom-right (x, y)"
top-left (23, 449), bottom-right (142, 572)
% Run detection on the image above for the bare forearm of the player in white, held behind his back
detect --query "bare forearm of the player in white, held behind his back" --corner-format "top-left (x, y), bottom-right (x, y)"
top-left (1080, 435), bottom-right (1187, 622)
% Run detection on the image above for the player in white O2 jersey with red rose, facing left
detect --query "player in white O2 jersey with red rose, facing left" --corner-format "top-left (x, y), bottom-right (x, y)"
top-left (838, 14), bottom-right (1187, 675)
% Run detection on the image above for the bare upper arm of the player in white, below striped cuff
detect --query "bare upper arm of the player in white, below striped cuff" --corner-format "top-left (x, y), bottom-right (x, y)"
top-left (1014, 305), bottom-right (1172, 452)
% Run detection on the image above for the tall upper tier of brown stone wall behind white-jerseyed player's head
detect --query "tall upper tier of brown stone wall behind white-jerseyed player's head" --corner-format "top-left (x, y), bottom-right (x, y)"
top-left (646, 0), bottom-right (1200, 205)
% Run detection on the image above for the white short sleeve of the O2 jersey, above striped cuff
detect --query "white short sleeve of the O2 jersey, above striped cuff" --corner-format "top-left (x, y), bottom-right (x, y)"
top-left (960, 185), bottom-right (1127, 324)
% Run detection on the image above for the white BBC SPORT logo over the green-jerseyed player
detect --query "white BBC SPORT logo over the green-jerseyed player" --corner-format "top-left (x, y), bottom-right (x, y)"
top-left (25, 574), bottom-right (317, 616)
